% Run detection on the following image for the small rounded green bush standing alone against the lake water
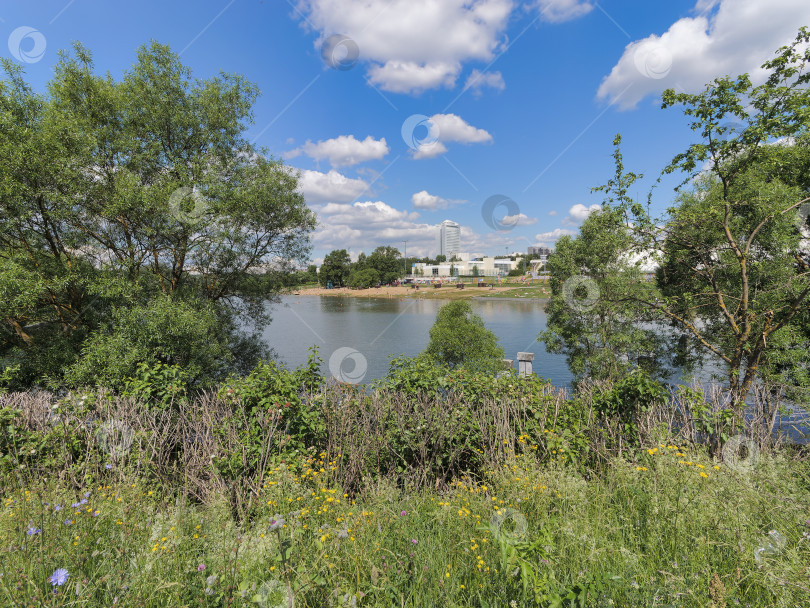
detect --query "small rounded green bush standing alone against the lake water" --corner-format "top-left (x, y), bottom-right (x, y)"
top-left (424, 300), bottom-right (504, 372)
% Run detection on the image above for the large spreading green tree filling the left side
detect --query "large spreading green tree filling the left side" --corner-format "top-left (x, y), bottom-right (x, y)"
top-left (0, 42), bottom-right (315, 384)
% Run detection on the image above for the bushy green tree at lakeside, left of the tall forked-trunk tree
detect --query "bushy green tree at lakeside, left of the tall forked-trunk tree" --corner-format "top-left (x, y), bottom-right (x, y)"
top-left (539, 206), bottom-right (668, 380)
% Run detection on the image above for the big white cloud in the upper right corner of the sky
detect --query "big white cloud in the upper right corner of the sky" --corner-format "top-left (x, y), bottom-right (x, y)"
top-left (597, 0), bottom-right (810, 109)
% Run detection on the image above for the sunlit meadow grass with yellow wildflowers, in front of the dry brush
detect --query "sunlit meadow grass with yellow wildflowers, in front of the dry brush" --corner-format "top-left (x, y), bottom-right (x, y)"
top-left (0, 444), bottom-right (810, 607)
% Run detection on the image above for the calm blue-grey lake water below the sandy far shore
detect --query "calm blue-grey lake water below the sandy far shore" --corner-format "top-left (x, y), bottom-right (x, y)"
top-left (264, 296), bottom-right (572, 386)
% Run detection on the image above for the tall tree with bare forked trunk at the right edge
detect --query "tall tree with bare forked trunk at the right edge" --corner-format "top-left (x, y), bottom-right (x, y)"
top-left (606, 28), bottom-right (810, 411)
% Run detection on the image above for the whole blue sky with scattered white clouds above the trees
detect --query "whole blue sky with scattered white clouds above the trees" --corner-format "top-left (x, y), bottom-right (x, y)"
top-left (6, 0), bottom-right (810, 262)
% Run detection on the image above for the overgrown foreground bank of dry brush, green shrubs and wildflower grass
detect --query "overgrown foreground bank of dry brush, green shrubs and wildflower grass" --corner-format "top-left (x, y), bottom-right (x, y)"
top-left (0, 367), bottom-right (810, 608)
